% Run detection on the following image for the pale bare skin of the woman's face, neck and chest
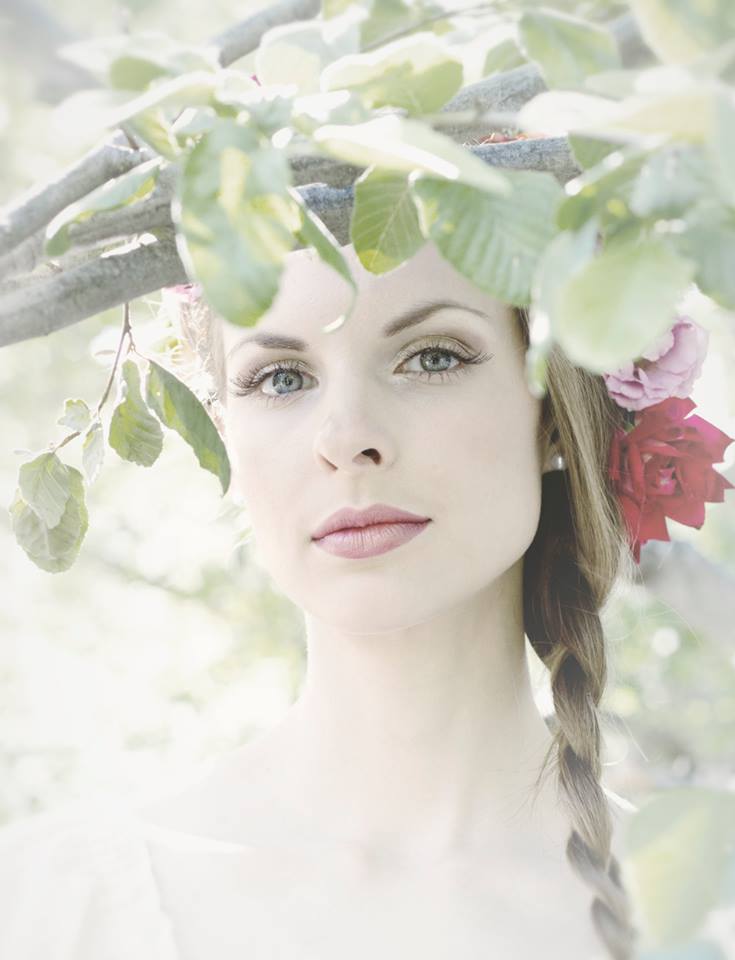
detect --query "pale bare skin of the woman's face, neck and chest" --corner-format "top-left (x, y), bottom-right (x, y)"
top-left (137, 243), bottom-right (616, 960)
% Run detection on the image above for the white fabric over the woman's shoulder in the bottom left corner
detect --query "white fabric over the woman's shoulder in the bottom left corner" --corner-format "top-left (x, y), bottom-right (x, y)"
top-left (0, 803), bottom-right (180, 960)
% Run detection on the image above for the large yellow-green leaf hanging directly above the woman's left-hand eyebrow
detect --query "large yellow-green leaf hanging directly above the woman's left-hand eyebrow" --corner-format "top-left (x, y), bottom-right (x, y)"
top-left (172, 118), bottom-right (302, 326)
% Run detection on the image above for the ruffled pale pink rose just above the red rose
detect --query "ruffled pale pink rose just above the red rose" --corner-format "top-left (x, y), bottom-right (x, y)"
top-left (602, 316), bottom-right (709, 410)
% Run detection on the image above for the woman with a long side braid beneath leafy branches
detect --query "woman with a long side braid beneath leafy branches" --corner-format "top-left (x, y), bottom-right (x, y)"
top-left (0, 243), bottom-right (634, 960)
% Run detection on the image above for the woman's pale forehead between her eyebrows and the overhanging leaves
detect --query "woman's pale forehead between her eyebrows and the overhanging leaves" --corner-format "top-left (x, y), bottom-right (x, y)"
top-left (222, 241), bottom-right (512, 353)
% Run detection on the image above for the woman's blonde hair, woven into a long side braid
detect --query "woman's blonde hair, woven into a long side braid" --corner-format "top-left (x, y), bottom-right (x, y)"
top-left (175, 292), bottom-right (637, 960)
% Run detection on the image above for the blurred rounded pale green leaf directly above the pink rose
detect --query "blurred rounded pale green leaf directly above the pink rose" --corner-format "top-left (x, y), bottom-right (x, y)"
top-left (551, 239), bottom-right (695, 373)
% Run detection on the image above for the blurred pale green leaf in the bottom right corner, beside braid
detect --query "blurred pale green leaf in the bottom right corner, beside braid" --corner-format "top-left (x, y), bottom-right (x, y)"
top-left (626, 787), bottom-right (735, 947)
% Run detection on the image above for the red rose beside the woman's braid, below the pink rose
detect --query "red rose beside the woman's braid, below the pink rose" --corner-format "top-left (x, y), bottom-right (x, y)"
top-left (609, 397), bottom-right (733, 563)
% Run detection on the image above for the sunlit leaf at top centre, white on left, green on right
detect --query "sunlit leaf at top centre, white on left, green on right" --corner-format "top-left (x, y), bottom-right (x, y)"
top-left (321, 33), bottom-right (463, 115)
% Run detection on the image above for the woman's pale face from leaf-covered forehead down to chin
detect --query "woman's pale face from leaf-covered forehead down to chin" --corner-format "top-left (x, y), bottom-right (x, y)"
top-left (223, 243), bottom-right (545, 634)
